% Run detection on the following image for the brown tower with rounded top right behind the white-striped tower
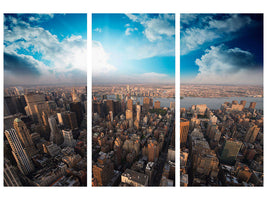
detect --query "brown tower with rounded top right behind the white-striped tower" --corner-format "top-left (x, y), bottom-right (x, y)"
top-left (13, 118), bottom-right (37, 157)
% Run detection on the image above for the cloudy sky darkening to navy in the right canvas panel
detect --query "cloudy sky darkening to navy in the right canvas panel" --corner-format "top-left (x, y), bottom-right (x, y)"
top-left (180, 14), bottom-right (263, 85)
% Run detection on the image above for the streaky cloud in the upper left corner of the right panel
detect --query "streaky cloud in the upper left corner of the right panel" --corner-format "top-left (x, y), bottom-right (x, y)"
top-left (181, 14), bottom-right (252, 55)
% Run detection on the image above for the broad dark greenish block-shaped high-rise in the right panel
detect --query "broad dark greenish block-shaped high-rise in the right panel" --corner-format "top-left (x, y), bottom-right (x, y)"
top-left (221, 139), bottom-right (242, 164)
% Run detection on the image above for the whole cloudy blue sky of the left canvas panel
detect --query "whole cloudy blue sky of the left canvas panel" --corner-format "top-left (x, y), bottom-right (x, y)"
top-left (4, 14), bottom-right (87, 86)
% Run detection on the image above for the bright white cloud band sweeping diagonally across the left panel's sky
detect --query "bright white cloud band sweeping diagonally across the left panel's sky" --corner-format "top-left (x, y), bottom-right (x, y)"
top-left (4, 16), bottom-right (87, 85)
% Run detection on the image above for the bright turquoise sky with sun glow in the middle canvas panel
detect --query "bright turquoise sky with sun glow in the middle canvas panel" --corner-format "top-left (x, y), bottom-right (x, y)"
top-left (92, 14), bottom-right (175, 84)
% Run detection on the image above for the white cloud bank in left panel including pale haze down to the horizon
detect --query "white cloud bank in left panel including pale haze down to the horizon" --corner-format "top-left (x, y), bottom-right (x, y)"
top-left (4, 15), bottom-right (87, 84)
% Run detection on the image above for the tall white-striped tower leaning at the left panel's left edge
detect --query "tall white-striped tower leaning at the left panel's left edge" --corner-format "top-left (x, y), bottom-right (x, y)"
top-left (5, 128), bottom-right (34, 175)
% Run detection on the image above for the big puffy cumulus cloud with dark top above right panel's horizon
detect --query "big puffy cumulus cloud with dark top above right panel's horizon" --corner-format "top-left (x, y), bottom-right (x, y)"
top-left (192, 45), bottom-right (263, 84)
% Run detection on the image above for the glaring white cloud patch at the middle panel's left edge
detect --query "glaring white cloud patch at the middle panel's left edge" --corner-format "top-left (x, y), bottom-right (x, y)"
top-left (92, 41), bottom-right (117, 76)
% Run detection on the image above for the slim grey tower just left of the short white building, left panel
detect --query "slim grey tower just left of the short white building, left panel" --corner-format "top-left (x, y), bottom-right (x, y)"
top-left (48, 116), bottom-right (64, 145)
